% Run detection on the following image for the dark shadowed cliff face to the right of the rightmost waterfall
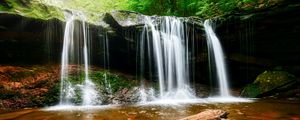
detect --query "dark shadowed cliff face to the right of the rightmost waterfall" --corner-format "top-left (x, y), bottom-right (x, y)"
top-left (216, 3), bottom-right (300, 83)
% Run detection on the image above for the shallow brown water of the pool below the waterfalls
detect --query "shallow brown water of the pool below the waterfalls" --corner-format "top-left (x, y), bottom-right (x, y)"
top-left (0, 100), bottom-right (300, 120)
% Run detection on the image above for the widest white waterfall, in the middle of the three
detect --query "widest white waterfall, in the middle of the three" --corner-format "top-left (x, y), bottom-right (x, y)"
top-left (140, 16), bottom-right (195, 100)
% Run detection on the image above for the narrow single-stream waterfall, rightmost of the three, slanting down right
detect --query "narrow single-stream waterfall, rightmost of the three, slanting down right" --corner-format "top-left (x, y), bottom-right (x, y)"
top-left (204, 20), bottom-right (231, 97)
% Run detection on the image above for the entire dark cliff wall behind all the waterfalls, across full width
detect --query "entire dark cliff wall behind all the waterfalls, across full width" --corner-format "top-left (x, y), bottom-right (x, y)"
top-left (0, 3), bottom-right (300, 86)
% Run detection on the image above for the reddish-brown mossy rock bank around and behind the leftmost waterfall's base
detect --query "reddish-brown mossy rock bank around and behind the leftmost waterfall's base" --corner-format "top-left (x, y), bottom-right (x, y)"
top-left (0, 65), bottom-right (140, 109)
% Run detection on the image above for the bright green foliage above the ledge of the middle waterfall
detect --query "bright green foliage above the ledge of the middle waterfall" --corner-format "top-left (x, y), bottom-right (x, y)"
top-left (128, 0), bottom-right (240, 17)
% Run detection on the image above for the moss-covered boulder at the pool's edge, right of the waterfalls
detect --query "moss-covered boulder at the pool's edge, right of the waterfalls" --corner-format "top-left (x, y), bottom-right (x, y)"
top-left (241, 71), bottom-right (296, 97)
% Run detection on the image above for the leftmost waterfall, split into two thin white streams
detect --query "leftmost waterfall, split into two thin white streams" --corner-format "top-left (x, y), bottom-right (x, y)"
top-left (60, 12), bottom-right (99, 105)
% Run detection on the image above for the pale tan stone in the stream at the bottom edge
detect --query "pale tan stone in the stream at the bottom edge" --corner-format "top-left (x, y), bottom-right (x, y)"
top-left (180, 109), bottom-right (229, 120)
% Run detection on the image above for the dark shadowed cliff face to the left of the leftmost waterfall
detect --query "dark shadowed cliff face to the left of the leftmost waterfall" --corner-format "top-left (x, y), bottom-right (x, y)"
top-left (0, 13), bottom-right (63, 64)
